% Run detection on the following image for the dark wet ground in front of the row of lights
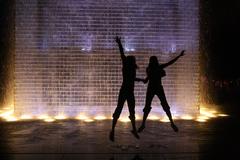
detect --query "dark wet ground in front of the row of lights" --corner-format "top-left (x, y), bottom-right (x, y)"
top-left (0, 117), bottom-right (240, 160)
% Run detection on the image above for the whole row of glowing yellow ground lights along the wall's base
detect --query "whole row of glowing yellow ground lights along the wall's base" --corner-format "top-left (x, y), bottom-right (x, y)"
top-left (0, 102), bottom-right (229, 123)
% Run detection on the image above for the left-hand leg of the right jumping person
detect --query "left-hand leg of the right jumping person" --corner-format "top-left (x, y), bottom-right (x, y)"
top-left (138, 89), bottom-right (154, 132)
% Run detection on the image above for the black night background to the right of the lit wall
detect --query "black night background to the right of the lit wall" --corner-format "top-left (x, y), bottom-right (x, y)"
top-left (200, 0), bottom-right (240, 117)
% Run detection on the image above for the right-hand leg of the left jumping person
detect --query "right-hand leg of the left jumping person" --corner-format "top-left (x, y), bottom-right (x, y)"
top-left (127, 92), bottom-right (140, 139)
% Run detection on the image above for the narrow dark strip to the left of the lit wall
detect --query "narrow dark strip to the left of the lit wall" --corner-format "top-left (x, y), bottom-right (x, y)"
top-left (0, 0), bottom-right (14, 106)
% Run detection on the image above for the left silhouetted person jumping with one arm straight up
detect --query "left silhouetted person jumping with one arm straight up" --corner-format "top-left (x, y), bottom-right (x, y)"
top-left (109, 37), bottom-right (144, 141)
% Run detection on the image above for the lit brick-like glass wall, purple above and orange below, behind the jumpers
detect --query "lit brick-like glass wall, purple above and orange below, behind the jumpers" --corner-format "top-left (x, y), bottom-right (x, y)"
top-left (14, 0), bottom-right (199, 116)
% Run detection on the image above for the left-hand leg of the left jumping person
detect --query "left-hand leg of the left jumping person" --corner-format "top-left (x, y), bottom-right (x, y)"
top-left (109, 90), bottom-right (126, 141)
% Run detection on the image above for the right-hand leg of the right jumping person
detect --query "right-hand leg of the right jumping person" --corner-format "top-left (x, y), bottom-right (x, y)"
top-left (157, 87), bottom-right (178, 132)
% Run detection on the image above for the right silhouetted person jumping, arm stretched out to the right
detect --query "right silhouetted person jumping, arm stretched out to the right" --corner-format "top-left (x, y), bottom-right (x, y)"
top-left (138, 50), bottom-right (184, 132)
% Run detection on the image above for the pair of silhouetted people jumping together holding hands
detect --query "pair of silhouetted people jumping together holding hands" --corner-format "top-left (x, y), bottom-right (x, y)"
top-left (109, 37), bottom-right (184, 141)
